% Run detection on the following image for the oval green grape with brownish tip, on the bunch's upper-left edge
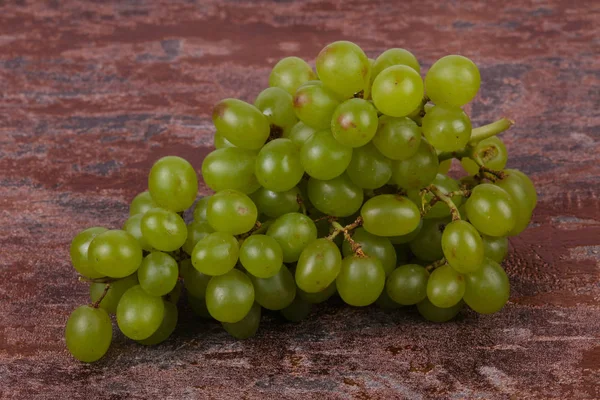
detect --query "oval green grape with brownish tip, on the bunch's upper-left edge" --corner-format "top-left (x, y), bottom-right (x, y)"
top-left (212, 99), bottom-right (271, 150)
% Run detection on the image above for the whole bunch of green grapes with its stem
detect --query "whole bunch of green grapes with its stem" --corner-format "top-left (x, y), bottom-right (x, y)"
top-left (66, 41), bottom-right (537, 362)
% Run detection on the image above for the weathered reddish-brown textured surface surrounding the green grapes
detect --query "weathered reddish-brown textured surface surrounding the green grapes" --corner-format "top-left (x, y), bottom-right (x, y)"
top-left (0, 0), bottom-right (600, 399)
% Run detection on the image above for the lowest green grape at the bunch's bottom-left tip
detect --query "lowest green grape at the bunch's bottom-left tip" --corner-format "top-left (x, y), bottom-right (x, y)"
top-left (65, 306), bottom-right (112, 362)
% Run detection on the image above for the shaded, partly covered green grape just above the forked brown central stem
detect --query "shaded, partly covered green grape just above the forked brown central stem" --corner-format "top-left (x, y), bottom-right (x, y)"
top-left (307, 174), bottom-right (364, 217)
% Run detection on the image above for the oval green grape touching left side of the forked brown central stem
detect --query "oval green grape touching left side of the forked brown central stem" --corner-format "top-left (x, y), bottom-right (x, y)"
top-left (295, 238), bottom-right (342, 293)
